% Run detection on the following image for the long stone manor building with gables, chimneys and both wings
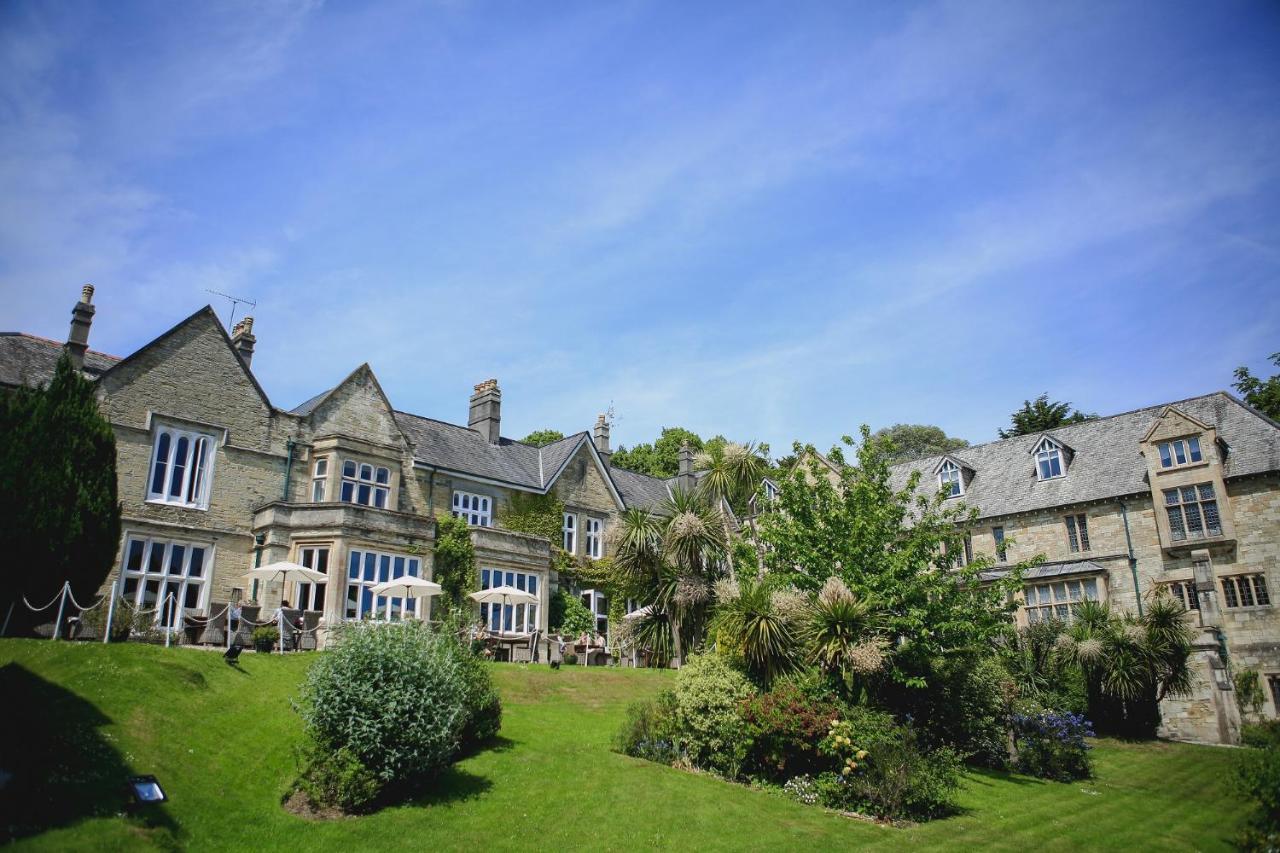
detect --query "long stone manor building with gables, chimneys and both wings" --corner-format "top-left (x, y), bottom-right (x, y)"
top-left (0, 286), bottom-right (1280, 742)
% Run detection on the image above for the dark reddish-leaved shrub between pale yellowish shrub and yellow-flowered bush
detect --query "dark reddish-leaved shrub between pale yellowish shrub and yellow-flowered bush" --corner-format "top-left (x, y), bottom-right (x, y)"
top-left (741, 681), bottom-right (844, 780)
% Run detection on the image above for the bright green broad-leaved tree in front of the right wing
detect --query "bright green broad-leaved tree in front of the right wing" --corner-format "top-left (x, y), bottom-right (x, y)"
top-left (760, 427), bottom-right (1025, 689)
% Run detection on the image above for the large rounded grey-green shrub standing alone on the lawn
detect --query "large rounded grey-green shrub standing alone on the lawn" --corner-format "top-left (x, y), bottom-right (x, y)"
top-left (300, 622), bottom-right (471, 784)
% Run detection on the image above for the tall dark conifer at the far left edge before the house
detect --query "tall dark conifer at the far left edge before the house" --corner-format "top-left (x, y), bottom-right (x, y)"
top-left (0, 355), bottom-right (120, 626)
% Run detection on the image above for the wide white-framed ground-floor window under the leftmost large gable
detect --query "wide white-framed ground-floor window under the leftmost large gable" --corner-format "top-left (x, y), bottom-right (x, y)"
top-left (116, 533), bottom-right (214, 628)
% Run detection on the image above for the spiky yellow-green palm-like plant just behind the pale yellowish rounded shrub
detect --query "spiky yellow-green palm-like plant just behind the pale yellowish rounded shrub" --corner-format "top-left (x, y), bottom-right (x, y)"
top-left (712, 578), bottom-right (796, 686)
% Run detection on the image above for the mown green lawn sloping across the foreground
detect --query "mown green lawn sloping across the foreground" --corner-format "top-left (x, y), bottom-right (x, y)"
top-left (0, 640), bottom-right (1243, 853)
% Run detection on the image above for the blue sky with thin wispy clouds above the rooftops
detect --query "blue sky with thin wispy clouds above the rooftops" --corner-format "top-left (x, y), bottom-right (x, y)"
top-left (0, 1), bottom-right (1280, 452)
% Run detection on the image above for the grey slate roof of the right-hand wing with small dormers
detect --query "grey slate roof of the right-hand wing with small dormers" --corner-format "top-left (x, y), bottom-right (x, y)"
top-left (892, 391), bottom-right (1280, 517)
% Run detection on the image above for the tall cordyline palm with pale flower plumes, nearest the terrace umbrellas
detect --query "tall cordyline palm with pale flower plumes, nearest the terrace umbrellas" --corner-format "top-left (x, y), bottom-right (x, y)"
top-left (613, 489), bottom-right (726, 666)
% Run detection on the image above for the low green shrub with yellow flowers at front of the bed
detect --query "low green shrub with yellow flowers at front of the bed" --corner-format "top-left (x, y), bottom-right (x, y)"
top-left (815, 710), bottom-right (960, 820)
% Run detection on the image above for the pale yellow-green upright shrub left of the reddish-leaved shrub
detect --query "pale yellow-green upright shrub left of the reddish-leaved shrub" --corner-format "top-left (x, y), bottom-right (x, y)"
top-left (673, 654), bottom-right (755, 777)
